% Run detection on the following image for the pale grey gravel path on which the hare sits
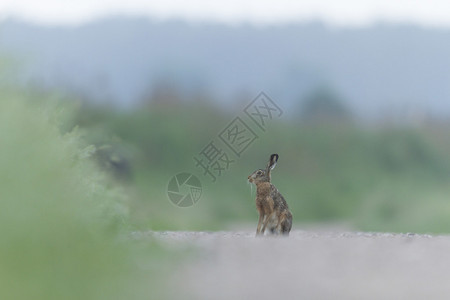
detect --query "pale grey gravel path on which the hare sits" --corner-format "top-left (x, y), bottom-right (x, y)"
top-left (141, 230), bottom-right (450, 300)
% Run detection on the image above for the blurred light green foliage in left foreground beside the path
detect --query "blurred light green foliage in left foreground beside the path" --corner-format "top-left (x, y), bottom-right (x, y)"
top-left (0, 91), bottom-right (176, 300)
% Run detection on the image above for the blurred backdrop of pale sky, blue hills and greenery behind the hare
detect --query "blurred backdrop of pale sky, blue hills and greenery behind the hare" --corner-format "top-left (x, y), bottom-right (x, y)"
top-left (0, 1), bottom-right (450, 232)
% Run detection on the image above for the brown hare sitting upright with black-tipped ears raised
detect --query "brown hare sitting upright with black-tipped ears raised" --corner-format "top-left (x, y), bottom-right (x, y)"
top-left (248, 154), bottom-right (292, 236)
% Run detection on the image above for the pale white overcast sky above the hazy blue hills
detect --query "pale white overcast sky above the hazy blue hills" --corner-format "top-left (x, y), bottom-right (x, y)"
top-left (0, 0), bottom-right (450, 28)
